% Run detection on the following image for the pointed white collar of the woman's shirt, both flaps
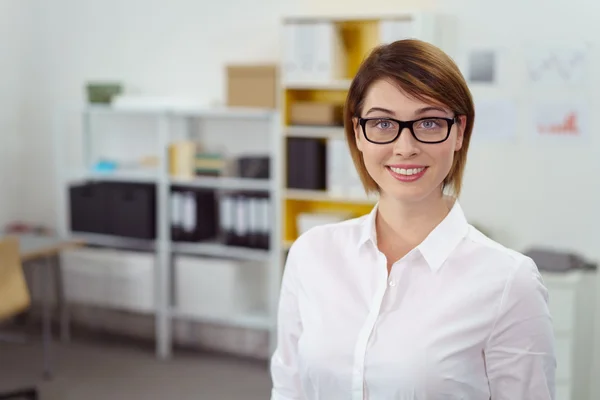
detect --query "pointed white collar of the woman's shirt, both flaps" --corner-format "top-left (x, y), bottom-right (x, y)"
top-left (358, 200), bottom-right (469, 272)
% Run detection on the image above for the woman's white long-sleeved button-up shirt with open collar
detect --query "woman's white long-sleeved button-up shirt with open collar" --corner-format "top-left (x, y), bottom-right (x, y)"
top-left (271, 202), bottom-right (556, 400)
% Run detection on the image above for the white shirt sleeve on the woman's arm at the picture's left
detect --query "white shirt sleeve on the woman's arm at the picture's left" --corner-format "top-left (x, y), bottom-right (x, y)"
top-left (271, 246), bottom-right (304, 400)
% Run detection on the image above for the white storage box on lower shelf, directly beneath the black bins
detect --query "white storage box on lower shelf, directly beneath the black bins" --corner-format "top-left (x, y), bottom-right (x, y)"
top-left (61, 248), bottom-right (154, 313)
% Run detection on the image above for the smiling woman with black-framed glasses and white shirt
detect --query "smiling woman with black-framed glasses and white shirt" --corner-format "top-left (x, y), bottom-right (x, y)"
top-left (271, 40), bottom-right (555, 400)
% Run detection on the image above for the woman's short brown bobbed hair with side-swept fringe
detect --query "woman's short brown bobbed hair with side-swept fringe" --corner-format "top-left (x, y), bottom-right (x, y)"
top-left (344, 39), bottom-right (475, 197)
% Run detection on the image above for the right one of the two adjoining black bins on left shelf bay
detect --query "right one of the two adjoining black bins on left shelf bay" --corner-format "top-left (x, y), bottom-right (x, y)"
top-left (107, 182), bottom-right (156, 239)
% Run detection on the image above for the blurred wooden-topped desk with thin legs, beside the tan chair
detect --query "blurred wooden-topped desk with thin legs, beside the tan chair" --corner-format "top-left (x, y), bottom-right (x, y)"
top-left (8, 234), bottom-right (82, 378)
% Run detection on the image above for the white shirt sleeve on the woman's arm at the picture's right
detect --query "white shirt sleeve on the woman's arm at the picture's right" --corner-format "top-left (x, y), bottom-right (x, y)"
top-left (485, 258), bottom-right (556, 400)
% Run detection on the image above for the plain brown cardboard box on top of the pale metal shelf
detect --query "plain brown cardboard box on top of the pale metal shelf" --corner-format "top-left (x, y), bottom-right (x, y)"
top-left (227, 65), bottom-right (277, 108)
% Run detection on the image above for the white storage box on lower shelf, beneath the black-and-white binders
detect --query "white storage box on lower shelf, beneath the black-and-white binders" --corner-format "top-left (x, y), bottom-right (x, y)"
top-left (175, 256), bottom-right (267, 318)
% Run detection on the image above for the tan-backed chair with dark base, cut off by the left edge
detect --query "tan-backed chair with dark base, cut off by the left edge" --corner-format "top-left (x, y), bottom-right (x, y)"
top-left (0, 237), bottom-right (38, 400)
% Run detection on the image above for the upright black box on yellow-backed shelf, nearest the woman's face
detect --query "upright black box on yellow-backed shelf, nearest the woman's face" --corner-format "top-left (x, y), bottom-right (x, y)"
top-left (287, 138), bottom-right (326, 190)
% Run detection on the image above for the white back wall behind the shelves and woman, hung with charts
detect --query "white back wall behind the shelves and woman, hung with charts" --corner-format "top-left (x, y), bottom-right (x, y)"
top-left (17, 0), bottom-right (600, 398)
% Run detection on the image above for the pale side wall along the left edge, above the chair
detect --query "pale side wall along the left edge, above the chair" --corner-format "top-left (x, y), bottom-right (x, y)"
top-left (0, 0), bottom-right (31, 230)
